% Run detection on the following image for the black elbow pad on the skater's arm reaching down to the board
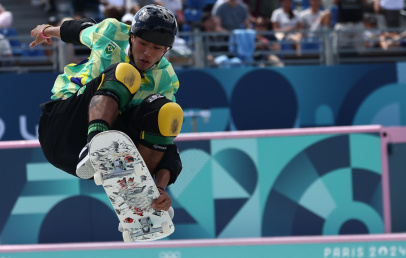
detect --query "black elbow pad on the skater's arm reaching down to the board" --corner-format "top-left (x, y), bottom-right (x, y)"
top-left (155, 144), bottom-right (182, 185)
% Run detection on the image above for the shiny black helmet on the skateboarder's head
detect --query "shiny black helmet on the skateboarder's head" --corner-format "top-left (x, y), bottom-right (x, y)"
top-left (130, 4), bottom-right (178, 47)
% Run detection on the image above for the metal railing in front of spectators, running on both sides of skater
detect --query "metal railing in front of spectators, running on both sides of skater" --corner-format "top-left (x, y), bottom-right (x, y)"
top-left (0, 27), bottom-right (406, 73)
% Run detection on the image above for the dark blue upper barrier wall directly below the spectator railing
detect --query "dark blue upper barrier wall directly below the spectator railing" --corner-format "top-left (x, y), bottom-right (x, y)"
top-left (0, 63), bottom-right (406, 140)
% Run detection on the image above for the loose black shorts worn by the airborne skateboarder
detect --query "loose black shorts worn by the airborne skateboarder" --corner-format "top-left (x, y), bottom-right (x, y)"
top-left (38, 77), bottom-right (141, 176)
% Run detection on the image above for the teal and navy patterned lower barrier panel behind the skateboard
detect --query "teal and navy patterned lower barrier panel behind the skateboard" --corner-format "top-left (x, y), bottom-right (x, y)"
top-left (0, 132), bottom-right (384, 244)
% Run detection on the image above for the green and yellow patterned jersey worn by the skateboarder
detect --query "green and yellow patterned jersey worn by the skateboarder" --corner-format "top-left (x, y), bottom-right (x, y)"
top-left (51, 19), bottom-right (179, 106)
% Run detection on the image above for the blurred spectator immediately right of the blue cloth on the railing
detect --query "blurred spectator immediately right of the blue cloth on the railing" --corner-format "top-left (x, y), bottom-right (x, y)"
top-left (254, 16), bottom-right (284, 67)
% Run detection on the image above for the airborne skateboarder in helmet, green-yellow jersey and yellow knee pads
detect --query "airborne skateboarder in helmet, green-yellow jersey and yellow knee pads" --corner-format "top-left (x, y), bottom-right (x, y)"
top-left (30, 5), bottom-right (183, 213)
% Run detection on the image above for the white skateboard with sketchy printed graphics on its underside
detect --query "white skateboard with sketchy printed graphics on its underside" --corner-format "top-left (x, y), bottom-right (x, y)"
top-left (89, 130), bottom-right (175, 242)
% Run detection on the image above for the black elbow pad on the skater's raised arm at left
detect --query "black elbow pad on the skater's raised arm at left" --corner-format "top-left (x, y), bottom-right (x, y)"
top-left (61, 18), bottom-right (97, 45)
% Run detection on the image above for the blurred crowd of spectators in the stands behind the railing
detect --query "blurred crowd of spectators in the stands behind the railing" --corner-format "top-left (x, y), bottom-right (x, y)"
top-left (0, 0), bottom-right (406, 66)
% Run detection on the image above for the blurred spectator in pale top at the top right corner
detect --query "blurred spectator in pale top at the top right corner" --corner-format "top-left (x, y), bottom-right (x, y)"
top-left (374, 0), bottom-right (405, 28)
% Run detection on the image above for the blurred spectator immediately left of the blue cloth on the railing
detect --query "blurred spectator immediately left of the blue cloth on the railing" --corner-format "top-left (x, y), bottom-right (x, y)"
top-left (201, 12), bottom-right (228, 64)
